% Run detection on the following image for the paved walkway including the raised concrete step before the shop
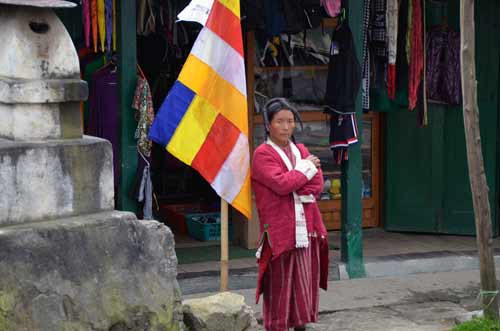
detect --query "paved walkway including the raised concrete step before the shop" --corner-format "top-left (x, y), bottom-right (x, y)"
top-left (178, 229), bottom-right (500, 331)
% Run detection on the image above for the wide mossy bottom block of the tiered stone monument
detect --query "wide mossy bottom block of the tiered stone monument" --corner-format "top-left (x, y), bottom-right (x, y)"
top-left (0, 211), bottom-right (182, 331)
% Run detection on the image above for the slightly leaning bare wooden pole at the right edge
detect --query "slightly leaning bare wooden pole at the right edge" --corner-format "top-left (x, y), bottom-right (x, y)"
top-left (460, 0), bottom-right (498, 319)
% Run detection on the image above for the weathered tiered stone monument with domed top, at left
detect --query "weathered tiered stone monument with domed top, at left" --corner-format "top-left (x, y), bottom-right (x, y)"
top-left (0, 0), bottom-right (182, 331)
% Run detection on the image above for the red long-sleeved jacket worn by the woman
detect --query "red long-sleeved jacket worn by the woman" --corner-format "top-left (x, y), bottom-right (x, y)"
top-left (252, 144), bottom-right (326, 258)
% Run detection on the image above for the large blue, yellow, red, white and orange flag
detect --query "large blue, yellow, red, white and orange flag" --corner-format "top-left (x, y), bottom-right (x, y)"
top-left (149, 0), bottom-right (251, 218)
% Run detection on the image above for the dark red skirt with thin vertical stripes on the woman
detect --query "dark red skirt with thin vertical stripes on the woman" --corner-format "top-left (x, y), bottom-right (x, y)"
top-left (262, 238), bottom-right (321, 331)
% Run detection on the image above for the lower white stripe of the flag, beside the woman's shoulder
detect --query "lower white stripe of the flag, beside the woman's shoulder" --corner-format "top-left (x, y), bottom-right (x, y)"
top-left (212, 134), bottom-right (250, 203)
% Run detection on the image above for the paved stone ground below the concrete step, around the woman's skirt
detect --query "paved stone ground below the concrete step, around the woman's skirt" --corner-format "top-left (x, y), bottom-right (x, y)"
top-left (186, 269), bottom-right (488, 331)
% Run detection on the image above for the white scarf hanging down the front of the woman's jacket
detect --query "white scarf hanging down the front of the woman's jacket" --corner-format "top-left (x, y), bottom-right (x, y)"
top-left (266, 139), bottom-right (315, 248)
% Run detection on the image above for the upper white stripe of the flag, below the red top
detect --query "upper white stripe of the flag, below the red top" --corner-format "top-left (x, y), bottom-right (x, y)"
top-left (191, 27), bottom-right (247, 97)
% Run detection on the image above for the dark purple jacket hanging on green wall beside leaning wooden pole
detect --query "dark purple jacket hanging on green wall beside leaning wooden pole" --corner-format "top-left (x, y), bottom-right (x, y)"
top-left (426, 27), bottom-right (462, 105)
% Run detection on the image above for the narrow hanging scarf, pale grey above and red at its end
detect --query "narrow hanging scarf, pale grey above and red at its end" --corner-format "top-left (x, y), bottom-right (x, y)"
top-left (386, 0), bottom-right (399, 99)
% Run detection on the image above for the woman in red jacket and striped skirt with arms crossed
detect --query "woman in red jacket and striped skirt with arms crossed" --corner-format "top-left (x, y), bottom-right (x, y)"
top-left (252, 98), bottom-right (328, 331)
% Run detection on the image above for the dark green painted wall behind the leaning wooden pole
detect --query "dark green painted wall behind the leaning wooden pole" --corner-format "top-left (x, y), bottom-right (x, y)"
top-left (383, 0), bottom-right (500, 235)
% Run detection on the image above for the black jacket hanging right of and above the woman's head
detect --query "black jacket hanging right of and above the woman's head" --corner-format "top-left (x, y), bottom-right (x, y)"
top-left (325, 22), bottom-right (361, 114)
